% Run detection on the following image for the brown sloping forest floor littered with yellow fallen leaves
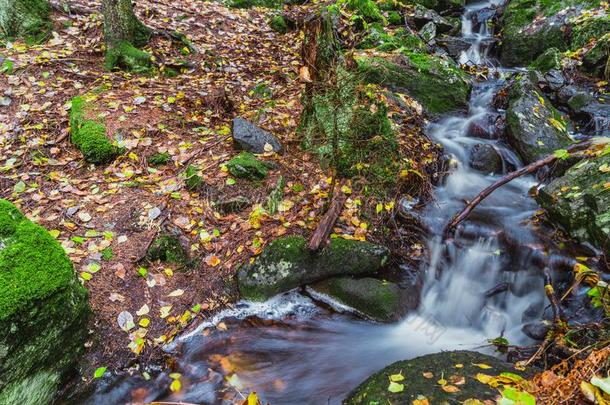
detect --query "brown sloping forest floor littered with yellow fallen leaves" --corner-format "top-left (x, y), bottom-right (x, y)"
top-left (0, 0), bottom-right (434, 380)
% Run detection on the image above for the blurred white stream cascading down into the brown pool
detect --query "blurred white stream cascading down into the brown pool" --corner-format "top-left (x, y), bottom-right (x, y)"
top-left (85, 1), bottom-right (564, 405)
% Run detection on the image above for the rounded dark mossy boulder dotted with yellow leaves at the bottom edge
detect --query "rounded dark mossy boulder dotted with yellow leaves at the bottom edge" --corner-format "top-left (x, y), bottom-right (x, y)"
top-left (343, 348), bottom-right (533, 405)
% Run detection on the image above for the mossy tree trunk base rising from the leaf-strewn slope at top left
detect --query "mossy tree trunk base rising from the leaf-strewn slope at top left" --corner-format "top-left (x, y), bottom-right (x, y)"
top-left (102, 0), bottom-right (150, 48)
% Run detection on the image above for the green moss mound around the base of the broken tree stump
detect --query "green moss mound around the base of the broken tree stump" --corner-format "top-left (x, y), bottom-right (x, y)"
top-left (299, 68), bottom-right (400, 192)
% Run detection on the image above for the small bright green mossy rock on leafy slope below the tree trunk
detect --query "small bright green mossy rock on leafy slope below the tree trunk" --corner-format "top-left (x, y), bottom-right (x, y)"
top-left (70, 95), bottom-right (119, 164)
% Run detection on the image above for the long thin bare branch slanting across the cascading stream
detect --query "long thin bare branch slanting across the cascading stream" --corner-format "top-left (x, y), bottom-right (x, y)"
top-left (443, 141), bottom-right (592, 239)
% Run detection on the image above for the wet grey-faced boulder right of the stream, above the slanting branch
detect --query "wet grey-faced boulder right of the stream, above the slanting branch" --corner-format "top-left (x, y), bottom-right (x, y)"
top-left (506, 75), bottom-right (571, 163)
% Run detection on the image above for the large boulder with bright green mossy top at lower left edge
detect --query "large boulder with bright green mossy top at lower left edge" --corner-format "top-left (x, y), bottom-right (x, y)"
top-left (0, 200), bottom-right (90, 405)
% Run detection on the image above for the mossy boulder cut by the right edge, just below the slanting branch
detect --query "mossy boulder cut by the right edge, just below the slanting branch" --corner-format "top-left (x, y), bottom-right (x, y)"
top-left (536, 150), bottom-right (610, 252)
